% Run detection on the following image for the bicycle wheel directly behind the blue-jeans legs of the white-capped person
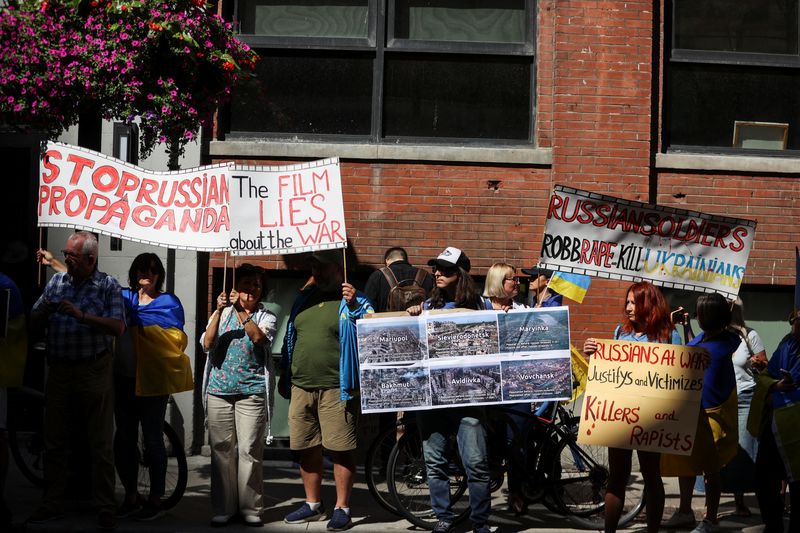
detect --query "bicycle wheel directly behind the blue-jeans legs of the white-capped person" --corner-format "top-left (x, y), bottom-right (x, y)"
top-left (387, 431), bottom-right (470, 530)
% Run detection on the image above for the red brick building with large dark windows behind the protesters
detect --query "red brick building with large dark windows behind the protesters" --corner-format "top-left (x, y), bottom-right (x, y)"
top-left (209, 0), bottom-right (800, 353)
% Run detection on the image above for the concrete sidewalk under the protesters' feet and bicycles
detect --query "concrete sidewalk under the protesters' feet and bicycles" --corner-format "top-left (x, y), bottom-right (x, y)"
top-left (6, 456), bottom-right (776, 533)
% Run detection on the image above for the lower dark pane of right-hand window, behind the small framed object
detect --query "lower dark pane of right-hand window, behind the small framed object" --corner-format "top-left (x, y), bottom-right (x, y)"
top-left (669, 63), bottom-right (800, 150)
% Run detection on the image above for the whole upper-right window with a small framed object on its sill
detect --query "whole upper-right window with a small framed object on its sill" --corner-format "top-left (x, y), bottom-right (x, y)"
top-left (665, 0), bottom-right (800, 155)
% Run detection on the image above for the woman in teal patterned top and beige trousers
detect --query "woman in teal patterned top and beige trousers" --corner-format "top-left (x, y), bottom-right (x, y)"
top-left (200, 263), bottom-right (277, 526)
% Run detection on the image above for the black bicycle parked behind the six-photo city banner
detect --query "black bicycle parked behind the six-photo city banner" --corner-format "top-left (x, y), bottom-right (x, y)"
top-left (387, 405), bottom-right (644, 529)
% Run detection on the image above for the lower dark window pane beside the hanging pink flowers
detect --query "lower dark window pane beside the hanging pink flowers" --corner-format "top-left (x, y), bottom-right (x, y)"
top-left (231, 50), bottom-right (374, 135)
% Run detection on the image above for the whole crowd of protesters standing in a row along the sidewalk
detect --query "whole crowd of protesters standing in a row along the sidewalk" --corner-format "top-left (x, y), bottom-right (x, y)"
top-left (0, 238), bottom-right (800, 533)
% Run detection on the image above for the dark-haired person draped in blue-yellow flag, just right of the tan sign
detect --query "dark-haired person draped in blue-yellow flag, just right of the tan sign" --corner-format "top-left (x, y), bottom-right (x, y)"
top-left (661, 293), bottom-right (741, 533)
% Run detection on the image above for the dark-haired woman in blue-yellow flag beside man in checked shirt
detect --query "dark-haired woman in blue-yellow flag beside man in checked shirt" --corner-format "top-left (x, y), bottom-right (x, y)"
top-left (114, 253), bottom-right (194, 520)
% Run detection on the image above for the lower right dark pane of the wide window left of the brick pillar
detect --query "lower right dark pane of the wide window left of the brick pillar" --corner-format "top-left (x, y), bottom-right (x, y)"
top-left (383, 55), bottom-right (532, 140)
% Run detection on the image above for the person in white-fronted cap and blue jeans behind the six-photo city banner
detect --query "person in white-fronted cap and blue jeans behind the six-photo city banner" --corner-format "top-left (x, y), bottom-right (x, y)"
top-left (408, 246), bottom-right (491, 533)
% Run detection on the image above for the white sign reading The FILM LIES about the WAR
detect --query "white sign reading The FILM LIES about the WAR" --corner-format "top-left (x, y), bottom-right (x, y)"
top-left (229, 158), bottom-right (347, 255)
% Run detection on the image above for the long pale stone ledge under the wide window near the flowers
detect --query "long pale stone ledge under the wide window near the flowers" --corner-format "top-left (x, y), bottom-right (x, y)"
top-left (209, 140), bottom-right (553, 165)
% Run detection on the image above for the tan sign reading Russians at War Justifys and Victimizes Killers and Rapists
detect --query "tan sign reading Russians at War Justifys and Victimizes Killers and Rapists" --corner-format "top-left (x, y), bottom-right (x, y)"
top-left (578, 340), bottom-right (709, 455)
